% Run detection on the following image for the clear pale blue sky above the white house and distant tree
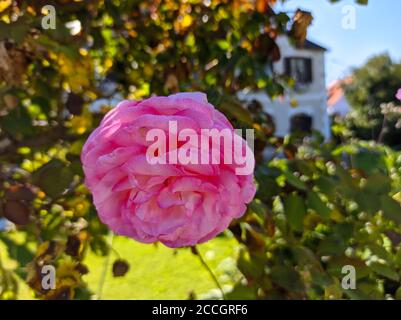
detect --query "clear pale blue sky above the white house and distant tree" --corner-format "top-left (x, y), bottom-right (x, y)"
top-left (278, 0), bottom-right (401, 84)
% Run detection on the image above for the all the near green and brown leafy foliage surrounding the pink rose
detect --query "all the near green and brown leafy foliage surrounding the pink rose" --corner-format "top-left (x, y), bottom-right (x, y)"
top-left (0, 0), bottom-right (401, 299)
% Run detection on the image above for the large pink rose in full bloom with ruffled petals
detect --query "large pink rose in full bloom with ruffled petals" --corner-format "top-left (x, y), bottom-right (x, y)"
top-left (81, 93), bottom-right (255, 247)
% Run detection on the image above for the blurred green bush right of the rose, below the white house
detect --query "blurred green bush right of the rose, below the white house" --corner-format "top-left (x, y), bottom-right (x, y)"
top-left (229, 139), bottom-right (401, 299)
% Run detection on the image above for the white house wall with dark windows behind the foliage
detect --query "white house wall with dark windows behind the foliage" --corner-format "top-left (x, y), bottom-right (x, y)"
top-left (239, 35), bottom-right (330, 139)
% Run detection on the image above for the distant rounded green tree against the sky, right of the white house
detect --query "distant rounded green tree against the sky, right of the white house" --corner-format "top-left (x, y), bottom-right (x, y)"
top-left (345, 54), bottom-right (401, 149)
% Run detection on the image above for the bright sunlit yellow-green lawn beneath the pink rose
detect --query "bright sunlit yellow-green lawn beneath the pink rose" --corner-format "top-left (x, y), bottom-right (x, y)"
top-left (0, 231), bottom-right (239, 299)
